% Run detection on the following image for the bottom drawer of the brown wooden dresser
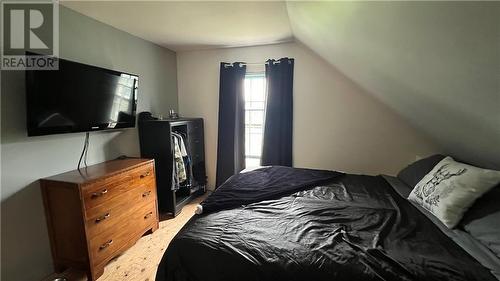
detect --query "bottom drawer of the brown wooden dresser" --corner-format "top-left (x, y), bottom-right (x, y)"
top-left (89, 200), bottom-right (158, 265)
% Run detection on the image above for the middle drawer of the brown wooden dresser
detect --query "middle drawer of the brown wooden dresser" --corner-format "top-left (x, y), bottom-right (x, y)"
top-left (85, 179), bottom-right (156, 222)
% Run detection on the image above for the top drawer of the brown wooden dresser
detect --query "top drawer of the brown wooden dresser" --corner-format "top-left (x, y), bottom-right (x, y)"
top-left (82, 164), bottom-right (154, 210)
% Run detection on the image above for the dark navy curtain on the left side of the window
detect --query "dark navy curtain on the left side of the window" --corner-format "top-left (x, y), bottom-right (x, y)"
top-left (216, 62), bottom-right (246, 187)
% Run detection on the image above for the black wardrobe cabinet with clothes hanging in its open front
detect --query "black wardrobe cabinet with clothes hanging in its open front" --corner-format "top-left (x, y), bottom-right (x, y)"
top-left (139, 112), bottom-right (207, 216)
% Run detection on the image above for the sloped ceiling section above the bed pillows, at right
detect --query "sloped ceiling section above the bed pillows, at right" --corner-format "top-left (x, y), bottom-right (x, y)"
top-left (287, 2), bottom-right (500, 168)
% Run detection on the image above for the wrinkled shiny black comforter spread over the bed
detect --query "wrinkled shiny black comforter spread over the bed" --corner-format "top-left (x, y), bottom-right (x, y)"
top-left (156, 166), bottom-right (496, 281)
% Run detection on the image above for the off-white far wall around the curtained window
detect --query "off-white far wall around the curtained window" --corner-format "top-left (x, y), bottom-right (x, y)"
top-left (177, 43), bottom-right (439, 187)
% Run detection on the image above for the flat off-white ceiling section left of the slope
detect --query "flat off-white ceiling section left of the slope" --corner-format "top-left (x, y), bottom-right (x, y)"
top-left (61, 1), bottom-right (293, 51)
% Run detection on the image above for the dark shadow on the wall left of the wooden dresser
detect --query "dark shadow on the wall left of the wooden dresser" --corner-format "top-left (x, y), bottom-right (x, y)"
top-left (1, 181), bottom-right (52, 281)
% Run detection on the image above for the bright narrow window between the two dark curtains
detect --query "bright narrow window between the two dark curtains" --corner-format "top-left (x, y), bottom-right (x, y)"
top-left (245, 73), bottom-right (266, 168)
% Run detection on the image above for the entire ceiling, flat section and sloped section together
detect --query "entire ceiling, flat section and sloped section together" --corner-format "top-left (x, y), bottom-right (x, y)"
top-left (62, 1), bottom-right (500, 169)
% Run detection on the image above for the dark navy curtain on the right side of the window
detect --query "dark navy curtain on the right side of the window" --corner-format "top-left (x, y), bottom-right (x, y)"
top-left (261, 58), bottom-right (294, 167)
